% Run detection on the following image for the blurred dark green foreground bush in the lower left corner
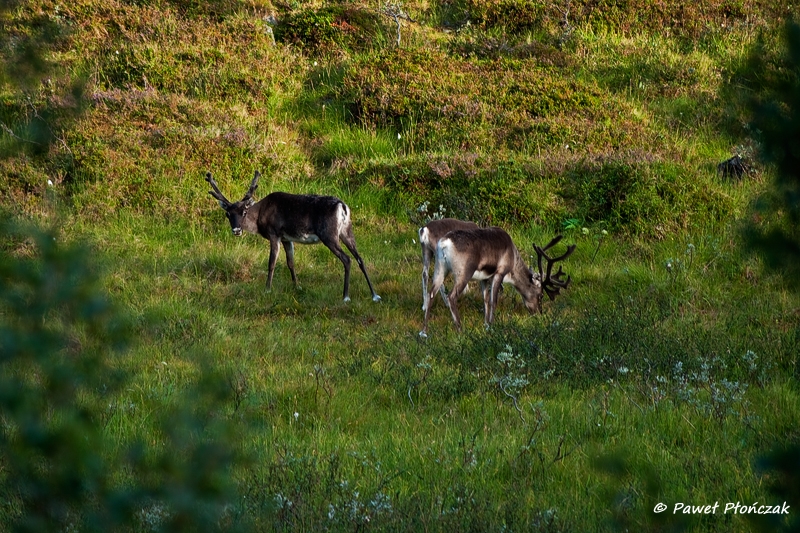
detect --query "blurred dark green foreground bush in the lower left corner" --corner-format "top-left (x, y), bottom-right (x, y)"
top-left (0, 219), bottom-right (245, 531)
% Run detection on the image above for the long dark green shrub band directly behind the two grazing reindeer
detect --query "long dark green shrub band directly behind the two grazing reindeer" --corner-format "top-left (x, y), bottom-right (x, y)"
top-left (346, 152), bottom-right (737, 233)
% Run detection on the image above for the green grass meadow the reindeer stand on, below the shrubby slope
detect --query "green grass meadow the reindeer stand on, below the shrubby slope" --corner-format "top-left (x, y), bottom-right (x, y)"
top-left (54, 211), bottom-right (800, 530)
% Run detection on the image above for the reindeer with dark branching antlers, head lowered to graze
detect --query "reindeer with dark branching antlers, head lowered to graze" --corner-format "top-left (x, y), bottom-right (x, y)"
top-left (420, 227), bottom-right (575, 337)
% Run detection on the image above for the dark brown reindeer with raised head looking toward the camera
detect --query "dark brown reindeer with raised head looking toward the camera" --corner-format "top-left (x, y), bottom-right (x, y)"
top-left (206, 171), bottom-right (381, 302)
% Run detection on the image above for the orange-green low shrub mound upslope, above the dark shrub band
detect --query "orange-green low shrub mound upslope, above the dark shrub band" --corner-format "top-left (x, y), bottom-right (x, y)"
top-left (337, 49), bottom-right (623, 152)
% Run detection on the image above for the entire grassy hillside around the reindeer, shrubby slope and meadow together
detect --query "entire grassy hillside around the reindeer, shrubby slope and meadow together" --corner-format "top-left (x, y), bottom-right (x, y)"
top-left (0, 0), bottom-right (800, 531)
